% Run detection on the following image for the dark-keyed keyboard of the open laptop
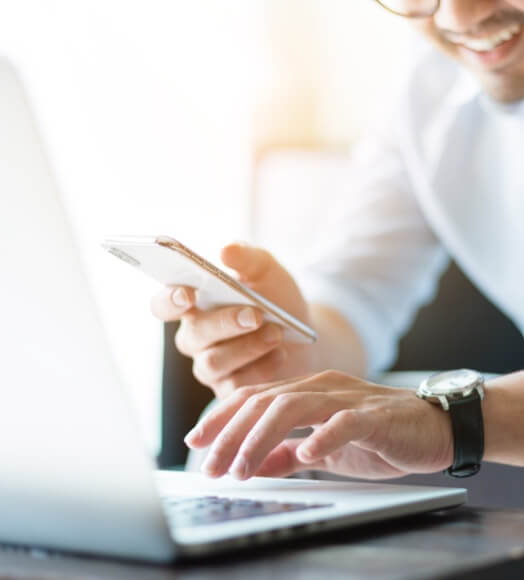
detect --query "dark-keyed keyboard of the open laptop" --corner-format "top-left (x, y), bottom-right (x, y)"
top-left (162, 496), bottom-right (332, 527)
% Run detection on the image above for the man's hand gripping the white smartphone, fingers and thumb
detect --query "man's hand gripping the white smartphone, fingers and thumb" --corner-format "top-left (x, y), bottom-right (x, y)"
top-left (151, 244), bottom-right (314, 398)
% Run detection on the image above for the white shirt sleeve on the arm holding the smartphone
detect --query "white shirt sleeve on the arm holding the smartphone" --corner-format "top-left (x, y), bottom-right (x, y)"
top-left (298, 135), bottom-right (448, 376)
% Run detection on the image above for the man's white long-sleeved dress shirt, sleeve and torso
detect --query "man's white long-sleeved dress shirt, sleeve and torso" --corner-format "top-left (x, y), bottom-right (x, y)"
top-left (301, 43), bottom-right (524, 374)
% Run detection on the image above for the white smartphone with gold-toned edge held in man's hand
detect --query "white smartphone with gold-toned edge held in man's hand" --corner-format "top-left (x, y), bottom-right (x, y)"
top-left (102, 236), bottom-right (317, 343)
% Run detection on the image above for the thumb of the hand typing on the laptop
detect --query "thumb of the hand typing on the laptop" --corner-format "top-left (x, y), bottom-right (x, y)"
top-left (297, 409), bottom-right (377, 463)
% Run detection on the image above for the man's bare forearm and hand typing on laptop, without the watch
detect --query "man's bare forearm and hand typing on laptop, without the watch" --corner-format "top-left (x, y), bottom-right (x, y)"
top-left (186, 371), bottom-right (524, 479)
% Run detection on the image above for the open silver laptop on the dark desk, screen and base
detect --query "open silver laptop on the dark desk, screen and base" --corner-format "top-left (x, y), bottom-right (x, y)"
top-left (0, 61), bottom-right (466, 562)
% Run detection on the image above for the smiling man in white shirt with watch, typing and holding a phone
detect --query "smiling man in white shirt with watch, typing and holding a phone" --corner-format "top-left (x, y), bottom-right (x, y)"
top-left (149, 0), bottom-right (524, 479)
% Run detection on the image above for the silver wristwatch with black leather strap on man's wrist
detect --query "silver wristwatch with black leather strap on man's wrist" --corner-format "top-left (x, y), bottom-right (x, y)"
top-left (417, 369), bottom-right (484, 477)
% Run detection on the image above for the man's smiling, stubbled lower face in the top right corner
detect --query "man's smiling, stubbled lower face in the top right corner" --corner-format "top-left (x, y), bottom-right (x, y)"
top-left (414, 0), bottom-right (524, 101)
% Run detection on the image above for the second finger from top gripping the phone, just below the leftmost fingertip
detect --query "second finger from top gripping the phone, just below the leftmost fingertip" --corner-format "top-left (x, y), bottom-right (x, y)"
top-left (175, 306), bottom-right (263, 356)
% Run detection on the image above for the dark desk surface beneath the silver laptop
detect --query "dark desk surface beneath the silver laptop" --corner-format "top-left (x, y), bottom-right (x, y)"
top-left (0, 507), bottom-right (524, 580)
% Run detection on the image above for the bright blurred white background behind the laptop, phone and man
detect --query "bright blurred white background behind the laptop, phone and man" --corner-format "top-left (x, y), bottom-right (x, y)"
top-left (0, 0), bottom-right (408, 449)
